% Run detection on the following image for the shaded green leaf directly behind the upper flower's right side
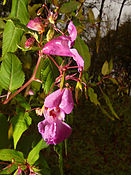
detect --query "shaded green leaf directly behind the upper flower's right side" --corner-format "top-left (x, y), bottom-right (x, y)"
top-left (75, 36), bottom-right (91, 71)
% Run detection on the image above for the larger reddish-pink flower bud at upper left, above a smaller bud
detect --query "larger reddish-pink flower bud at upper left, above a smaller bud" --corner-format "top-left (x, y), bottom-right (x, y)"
top-left (27, 17), bottom-right (45, 33)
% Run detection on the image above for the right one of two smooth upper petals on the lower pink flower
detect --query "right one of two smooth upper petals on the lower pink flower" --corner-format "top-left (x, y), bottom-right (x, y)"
top-left (59, 88), bottom-right (74, 114)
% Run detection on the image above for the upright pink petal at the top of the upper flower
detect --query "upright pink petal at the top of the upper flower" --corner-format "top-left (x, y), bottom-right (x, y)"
top-left (68, 21), bottom-right (77, 42)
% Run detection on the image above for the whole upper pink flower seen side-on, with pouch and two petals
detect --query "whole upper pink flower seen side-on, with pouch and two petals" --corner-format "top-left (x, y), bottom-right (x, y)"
top-left (43, 21), bottom-right (84, 70)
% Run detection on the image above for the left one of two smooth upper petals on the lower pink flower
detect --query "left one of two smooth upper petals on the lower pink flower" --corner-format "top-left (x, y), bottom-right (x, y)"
top-left (44, 89), bottom-right (63, 108)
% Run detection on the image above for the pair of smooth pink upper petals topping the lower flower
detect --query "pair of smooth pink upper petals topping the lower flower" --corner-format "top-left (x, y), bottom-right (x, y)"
top-left (44, 88), bottom-right (74, 114)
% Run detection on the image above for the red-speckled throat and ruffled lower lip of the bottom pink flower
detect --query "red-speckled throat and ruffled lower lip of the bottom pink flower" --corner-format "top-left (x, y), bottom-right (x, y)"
top-left (38, 107), bottom-right (72, 145)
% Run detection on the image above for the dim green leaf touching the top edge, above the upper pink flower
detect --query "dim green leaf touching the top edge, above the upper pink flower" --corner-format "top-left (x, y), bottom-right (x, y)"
top-left (60, 1), bottom-right (79, 13)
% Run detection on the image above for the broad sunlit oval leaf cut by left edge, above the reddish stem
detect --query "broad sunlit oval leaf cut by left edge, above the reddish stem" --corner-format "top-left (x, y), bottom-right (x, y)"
top-left (0, 53), bottom-right (25, 91)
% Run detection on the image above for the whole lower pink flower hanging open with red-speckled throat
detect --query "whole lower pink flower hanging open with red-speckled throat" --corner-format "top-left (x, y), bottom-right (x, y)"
top-left (38, 88), bottom-right (74, 145)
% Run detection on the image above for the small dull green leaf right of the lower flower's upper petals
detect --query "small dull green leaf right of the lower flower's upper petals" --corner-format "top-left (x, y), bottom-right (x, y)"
top-left (88, 87), bottom-right (100, 105)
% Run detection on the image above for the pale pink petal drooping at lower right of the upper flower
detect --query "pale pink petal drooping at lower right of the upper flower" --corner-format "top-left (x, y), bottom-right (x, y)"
top-left (70, 49), bottom-right (84, 71)
